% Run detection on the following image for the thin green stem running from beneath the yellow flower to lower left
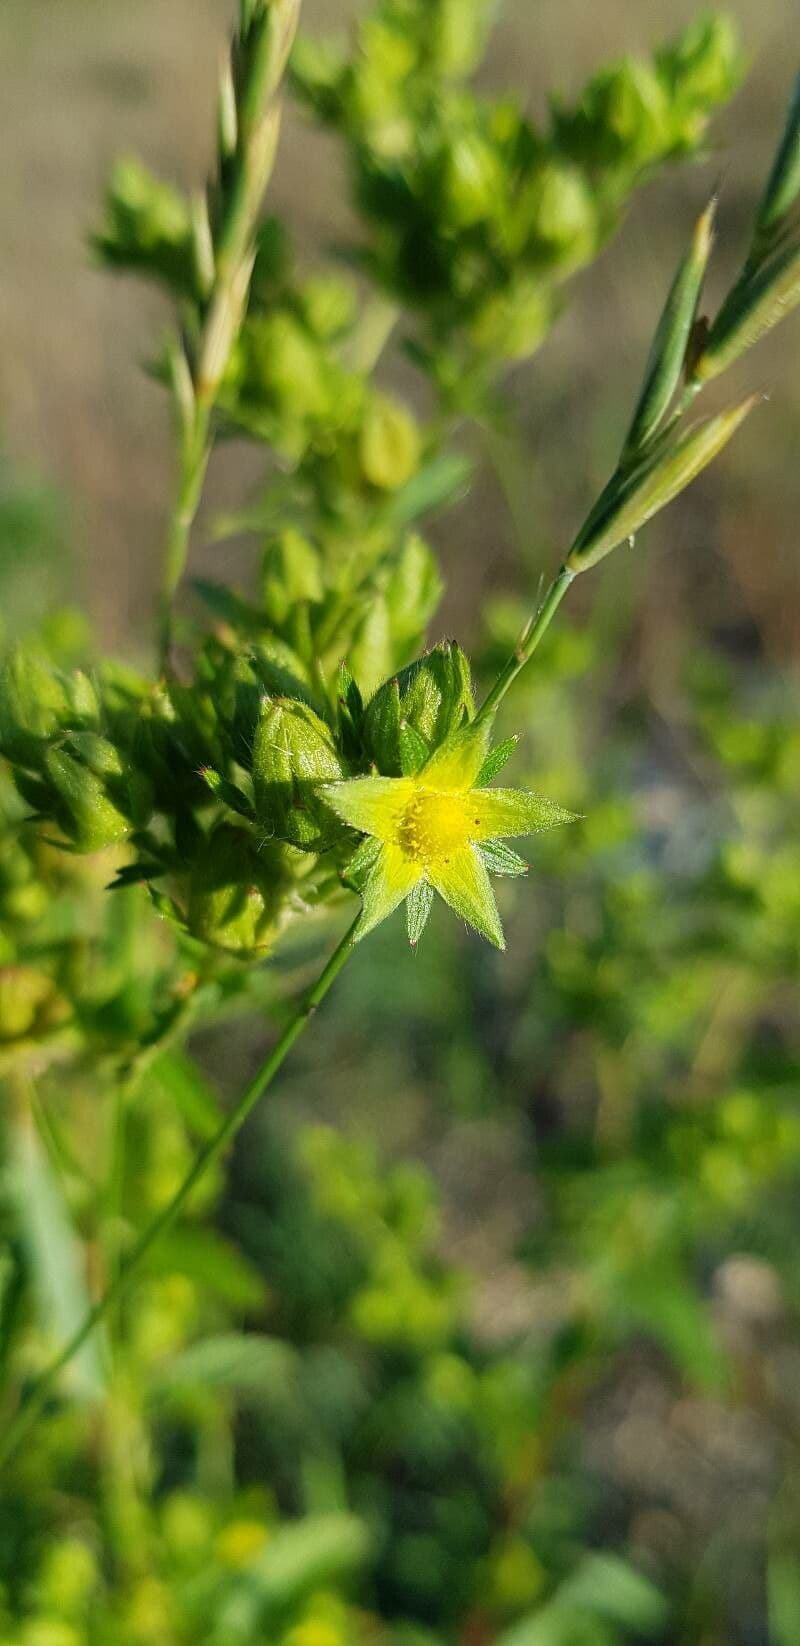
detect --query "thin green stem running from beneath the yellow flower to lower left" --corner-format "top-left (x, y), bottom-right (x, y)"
top-left (0, 922), bottom-right (356, 1467)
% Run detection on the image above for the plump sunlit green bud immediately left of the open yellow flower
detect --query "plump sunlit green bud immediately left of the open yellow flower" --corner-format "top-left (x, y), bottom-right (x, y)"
top-left (252, 698), bottom-right (344, 851)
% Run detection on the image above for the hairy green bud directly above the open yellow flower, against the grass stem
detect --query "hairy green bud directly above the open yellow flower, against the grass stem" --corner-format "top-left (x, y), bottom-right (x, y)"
top-left (364, 640), bottom-right (474, 777)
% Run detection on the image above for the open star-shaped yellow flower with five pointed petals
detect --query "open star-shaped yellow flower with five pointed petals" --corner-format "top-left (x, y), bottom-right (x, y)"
top-left (321, 724), bottom-right (574, 948)
